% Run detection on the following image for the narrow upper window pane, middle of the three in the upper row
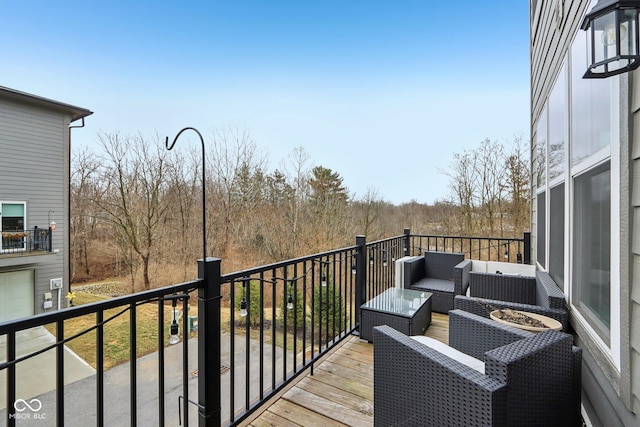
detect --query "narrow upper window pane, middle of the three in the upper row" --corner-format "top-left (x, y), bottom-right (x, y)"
top-left (549, 65), bottom-right (567, 180)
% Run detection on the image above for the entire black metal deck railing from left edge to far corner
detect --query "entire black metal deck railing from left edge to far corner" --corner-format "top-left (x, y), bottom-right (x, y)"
top-left (0, 229), bottom-right (524, 426)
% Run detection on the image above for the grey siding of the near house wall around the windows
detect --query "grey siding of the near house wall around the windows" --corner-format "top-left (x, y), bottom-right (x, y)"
top-left (530, 0), bottom-right (640, 426)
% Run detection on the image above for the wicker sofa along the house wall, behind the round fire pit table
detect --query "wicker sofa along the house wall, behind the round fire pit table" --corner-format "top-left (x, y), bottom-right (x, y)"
top-left (454, 271), bottom-right (569, 332)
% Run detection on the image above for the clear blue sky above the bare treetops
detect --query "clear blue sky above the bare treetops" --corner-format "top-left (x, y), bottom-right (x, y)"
top-left (0, 0), bottom-right (529, 203)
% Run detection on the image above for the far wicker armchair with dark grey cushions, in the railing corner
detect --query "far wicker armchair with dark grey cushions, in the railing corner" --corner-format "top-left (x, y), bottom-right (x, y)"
top-left (403, 251), bottom-right (471, 314)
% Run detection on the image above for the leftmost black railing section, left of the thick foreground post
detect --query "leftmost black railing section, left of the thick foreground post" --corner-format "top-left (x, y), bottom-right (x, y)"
top-left (0, 281), bottom-right (201, 426)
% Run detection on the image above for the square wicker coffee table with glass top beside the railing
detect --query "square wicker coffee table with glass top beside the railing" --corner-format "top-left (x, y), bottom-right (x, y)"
top-left (360, 288), bottom-right (432, 342)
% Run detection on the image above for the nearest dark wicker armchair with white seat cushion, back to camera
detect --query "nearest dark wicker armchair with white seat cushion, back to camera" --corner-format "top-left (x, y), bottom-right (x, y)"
top-left (374, 310), bottom-right (582, 426)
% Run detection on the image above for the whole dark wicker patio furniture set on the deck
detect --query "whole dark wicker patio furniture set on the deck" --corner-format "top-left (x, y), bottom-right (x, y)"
top-left (361, 252), bottom-right (582, 426)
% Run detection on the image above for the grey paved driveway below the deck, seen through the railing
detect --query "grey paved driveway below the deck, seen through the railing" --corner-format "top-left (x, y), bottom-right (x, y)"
top-left (0, 334), bottom-right (293, 427)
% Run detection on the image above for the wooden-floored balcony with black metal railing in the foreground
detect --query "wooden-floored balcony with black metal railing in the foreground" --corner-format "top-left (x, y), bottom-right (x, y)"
top-left (0, 230), bottom-right (544, 426)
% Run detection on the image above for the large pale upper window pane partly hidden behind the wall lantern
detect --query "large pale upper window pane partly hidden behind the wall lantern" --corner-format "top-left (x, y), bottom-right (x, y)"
top-left (571, 31), bottom-right (611, 165)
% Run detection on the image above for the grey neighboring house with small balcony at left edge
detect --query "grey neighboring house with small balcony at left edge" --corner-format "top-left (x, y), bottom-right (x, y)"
top-left (0, 86), bottom-right (92, 322)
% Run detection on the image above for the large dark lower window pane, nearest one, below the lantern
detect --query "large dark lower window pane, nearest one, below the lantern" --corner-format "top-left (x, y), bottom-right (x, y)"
top-left (573, 162), bottom-right (611, 343)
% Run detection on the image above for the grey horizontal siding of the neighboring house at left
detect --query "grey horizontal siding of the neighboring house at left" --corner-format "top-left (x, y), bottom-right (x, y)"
top-left (0, 88), bottom-right (91, 313)
